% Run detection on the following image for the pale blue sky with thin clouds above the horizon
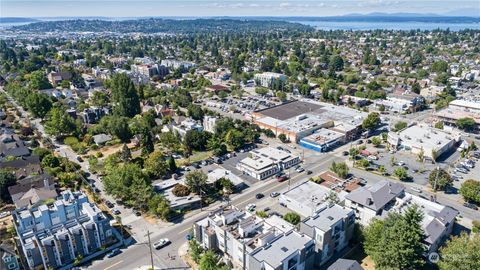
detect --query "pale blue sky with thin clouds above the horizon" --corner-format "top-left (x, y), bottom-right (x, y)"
top-left (0, 0), bottom-right (480, 17)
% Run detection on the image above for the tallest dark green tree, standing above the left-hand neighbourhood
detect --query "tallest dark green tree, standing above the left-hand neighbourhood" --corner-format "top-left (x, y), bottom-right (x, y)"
top-left (111, 73), bottom-right (140, 117)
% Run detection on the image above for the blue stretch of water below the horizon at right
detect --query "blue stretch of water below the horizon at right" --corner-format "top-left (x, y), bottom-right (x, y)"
top-left (294, 21), bottom-right (480, 31)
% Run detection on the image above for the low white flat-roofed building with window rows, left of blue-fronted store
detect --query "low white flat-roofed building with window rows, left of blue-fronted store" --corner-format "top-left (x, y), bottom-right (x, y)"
top-left (236, 147), bottom-right (300, 180)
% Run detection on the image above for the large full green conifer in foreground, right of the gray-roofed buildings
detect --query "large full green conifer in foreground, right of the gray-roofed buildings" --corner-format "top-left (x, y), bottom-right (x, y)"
top-left (364, 205), bottom-right (425, 270)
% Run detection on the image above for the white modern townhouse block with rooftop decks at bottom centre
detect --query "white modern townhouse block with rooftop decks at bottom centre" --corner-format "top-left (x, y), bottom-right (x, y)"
top-left (194, 207), bottom-right (314, 270)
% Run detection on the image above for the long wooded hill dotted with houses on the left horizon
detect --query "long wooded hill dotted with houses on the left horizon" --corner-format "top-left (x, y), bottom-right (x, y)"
top-left (11, 18), bottom-right (313, 33)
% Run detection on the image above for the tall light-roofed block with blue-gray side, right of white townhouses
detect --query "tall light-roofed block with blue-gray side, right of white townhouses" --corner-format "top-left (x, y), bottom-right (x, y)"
top-left (300, 203), bottom-right (355, 266)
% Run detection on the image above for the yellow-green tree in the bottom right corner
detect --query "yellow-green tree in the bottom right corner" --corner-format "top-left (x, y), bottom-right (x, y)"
top-left (438, 232), bottom-right (480, 270)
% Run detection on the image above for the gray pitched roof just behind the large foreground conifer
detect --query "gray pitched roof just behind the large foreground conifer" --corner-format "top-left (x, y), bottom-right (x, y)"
top-left (345, 180), bottom-right (405, 211)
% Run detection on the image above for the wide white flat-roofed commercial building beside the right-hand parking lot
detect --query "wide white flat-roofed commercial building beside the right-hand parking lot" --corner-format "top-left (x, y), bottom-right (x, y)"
top-left (387, 124), bottom-right (460, 160)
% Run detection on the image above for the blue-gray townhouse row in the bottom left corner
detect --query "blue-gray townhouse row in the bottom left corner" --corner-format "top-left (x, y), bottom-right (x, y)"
top-left (12, 190), bottom-right (113, 269)
